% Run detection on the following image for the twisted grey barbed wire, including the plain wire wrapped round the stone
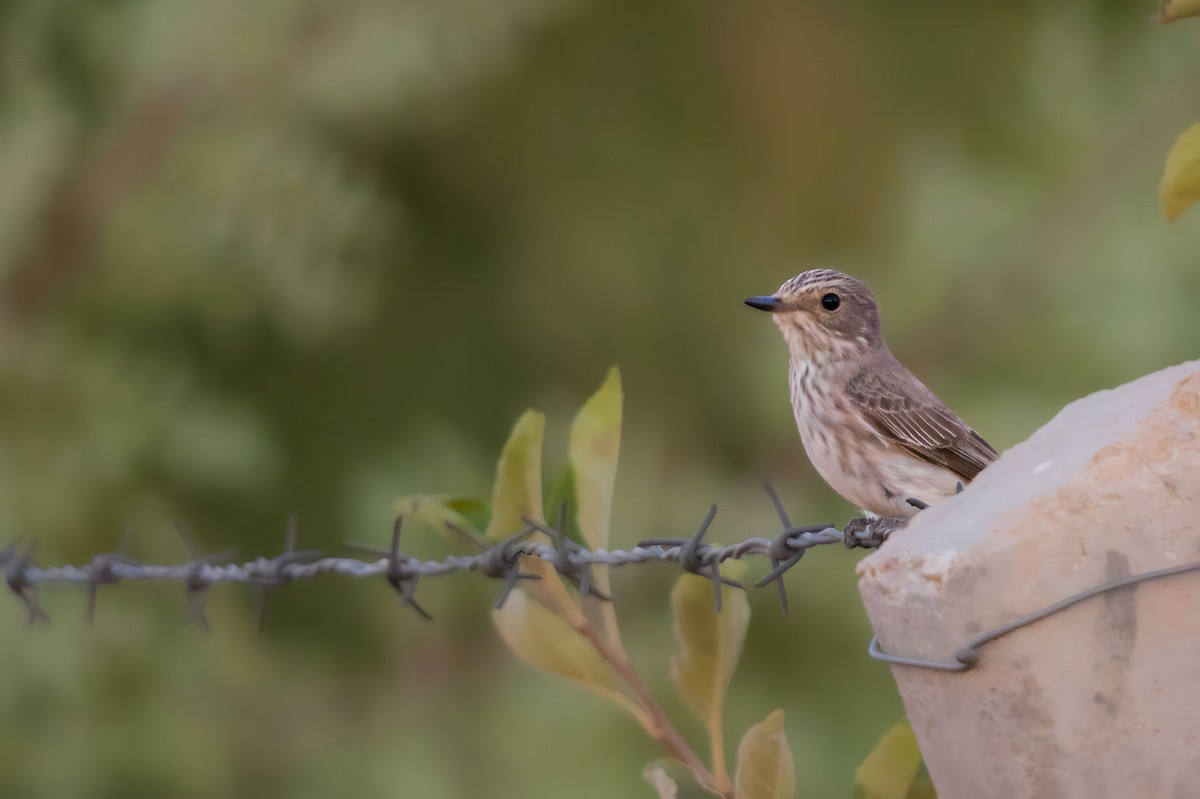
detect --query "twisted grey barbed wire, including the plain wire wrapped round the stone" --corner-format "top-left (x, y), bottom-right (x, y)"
top-left (0, 485), bottom-right (1200, 672)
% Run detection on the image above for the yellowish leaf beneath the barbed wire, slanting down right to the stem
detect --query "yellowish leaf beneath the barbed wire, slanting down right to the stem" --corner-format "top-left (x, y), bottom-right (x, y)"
top-left (492, 589), bottom-right (650, 727)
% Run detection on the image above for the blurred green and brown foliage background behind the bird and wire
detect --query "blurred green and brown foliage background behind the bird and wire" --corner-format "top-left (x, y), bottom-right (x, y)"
top-left (0, 0), bottom-right (1200, 798)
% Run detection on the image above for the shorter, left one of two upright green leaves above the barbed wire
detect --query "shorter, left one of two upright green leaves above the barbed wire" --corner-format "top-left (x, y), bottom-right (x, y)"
top-left (487, 410), bottom-right (546, 541)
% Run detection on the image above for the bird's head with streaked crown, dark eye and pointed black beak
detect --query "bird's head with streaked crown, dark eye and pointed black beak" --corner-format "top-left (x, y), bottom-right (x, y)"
top-left (745, 269), bottom-right (882, 359)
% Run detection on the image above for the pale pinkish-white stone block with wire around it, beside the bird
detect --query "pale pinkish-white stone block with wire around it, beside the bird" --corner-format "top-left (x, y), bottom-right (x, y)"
top-left (858, 361), bottom-right (1200, 799)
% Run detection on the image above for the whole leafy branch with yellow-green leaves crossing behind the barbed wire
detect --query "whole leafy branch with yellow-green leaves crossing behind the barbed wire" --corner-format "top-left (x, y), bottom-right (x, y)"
top-left (451, 368), bottom-right (794, 799)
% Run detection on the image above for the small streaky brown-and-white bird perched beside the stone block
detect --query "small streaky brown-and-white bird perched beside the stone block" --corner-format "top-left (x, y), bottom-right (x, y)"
top-left (745, 269), bottom-right (998, 523)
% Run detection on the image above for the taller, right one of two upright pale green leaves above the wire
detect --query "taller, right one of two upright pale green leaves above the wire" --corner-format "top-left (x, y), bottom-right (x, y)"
top-left (569, 366), bottom-right (623, 549)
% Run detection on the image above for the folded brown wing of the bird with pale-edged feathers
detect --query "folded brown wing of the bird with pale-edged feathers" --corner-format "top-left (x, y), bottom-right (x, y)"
top-left (846, 364), bottom-right (998, 482)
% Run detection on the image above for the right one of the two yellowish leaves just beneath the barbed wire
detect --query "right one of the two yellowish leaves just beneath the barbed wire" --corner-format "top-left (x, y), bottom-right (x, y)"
top-left (671, 563), bottom-right (750, 783)
